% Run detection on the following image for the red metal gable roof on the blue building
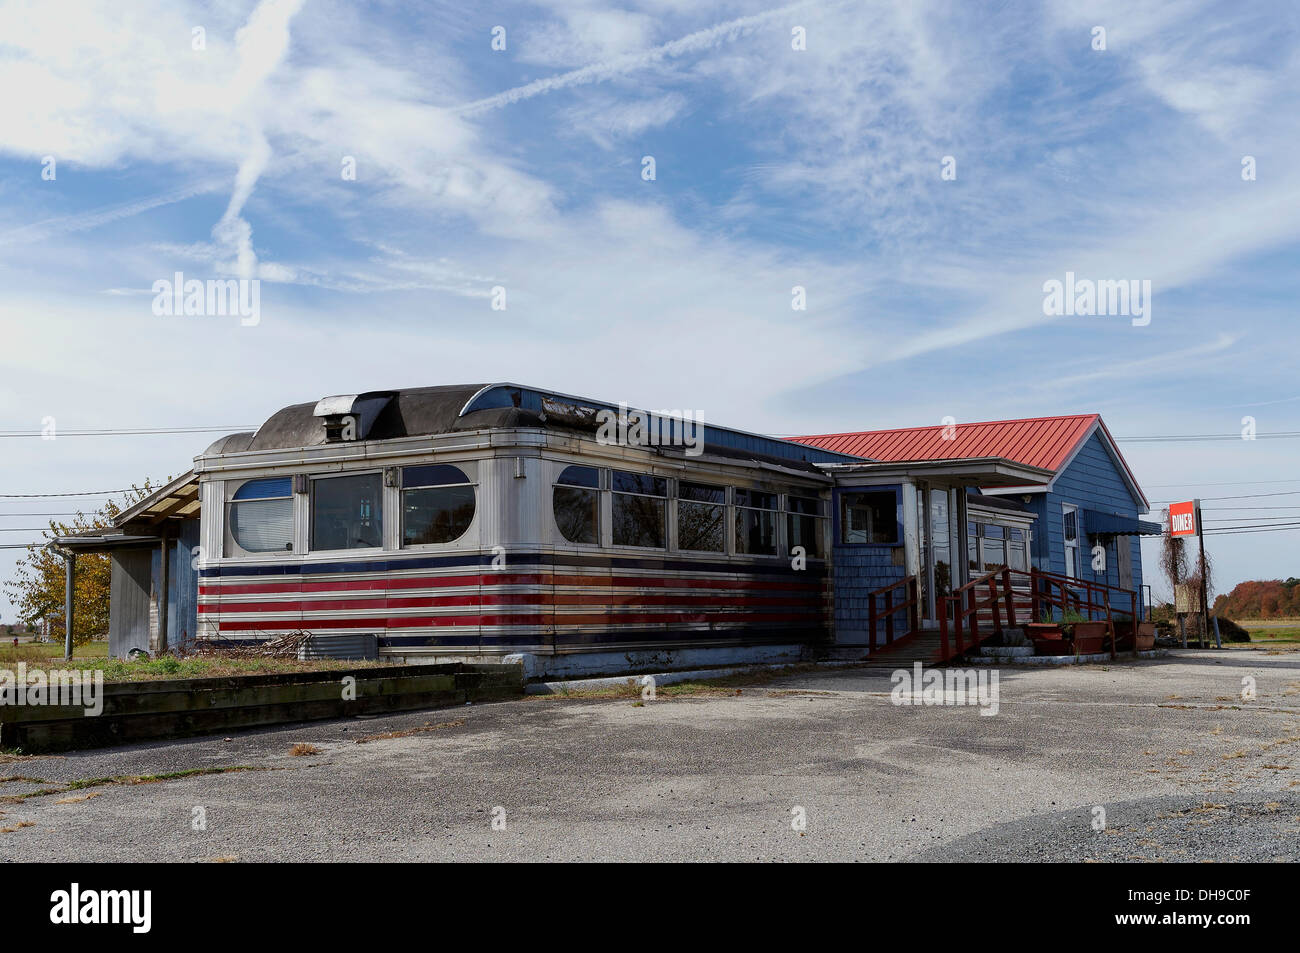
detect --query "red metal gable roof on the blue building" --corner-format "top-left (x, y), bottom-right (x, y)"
top-left (790, 413), bottom-right (1151, 510)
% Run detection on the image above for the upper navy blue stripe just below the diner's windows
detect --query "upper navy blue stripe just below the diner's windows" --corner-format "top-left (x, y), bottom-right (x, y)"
top-left (199, 551), bottom-right (826, 579)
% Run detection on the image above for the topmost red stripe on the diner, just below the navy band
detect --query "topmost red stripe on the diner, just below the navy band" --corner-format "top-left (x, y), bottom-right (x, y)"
top-left (199, 573), bottom-right (823, 595)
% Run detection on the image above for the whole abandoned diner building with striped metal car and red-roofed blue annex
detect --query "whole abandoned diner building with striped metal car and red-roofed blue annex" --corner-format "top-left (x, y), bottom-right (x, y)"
top-left (51, 384), bottom-right (1161, 677)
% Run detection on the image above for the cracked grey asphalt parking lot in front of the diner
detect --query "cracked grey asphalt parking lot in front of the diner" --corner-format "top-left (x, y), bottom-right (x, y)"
top-left (0, 650), bottom-right (1300, 861)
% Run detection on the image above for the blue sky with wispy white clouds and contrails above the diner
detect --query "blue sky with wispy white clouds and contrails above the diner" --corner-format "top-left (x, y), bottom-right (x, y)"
top-left (0, 0), bottom-right (1300, 620)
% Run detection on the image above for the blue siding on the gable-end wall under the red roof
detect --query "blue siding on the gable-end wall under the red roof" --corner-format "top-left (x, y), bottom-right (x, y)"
top-left (998, 433), bottom-right (1141, 611)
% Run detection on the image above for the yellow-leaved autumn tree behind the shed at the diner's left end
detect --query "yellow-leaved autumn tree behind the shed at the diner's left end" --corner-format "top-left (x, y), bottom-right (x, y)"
top-left (4, 480), bottom-right (157, 645)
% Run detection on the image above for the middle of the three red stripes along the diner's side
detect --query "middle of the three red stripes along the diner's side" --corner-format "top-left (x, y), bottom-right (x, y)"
top-left (199, 592), bottom-right (820, 614)
